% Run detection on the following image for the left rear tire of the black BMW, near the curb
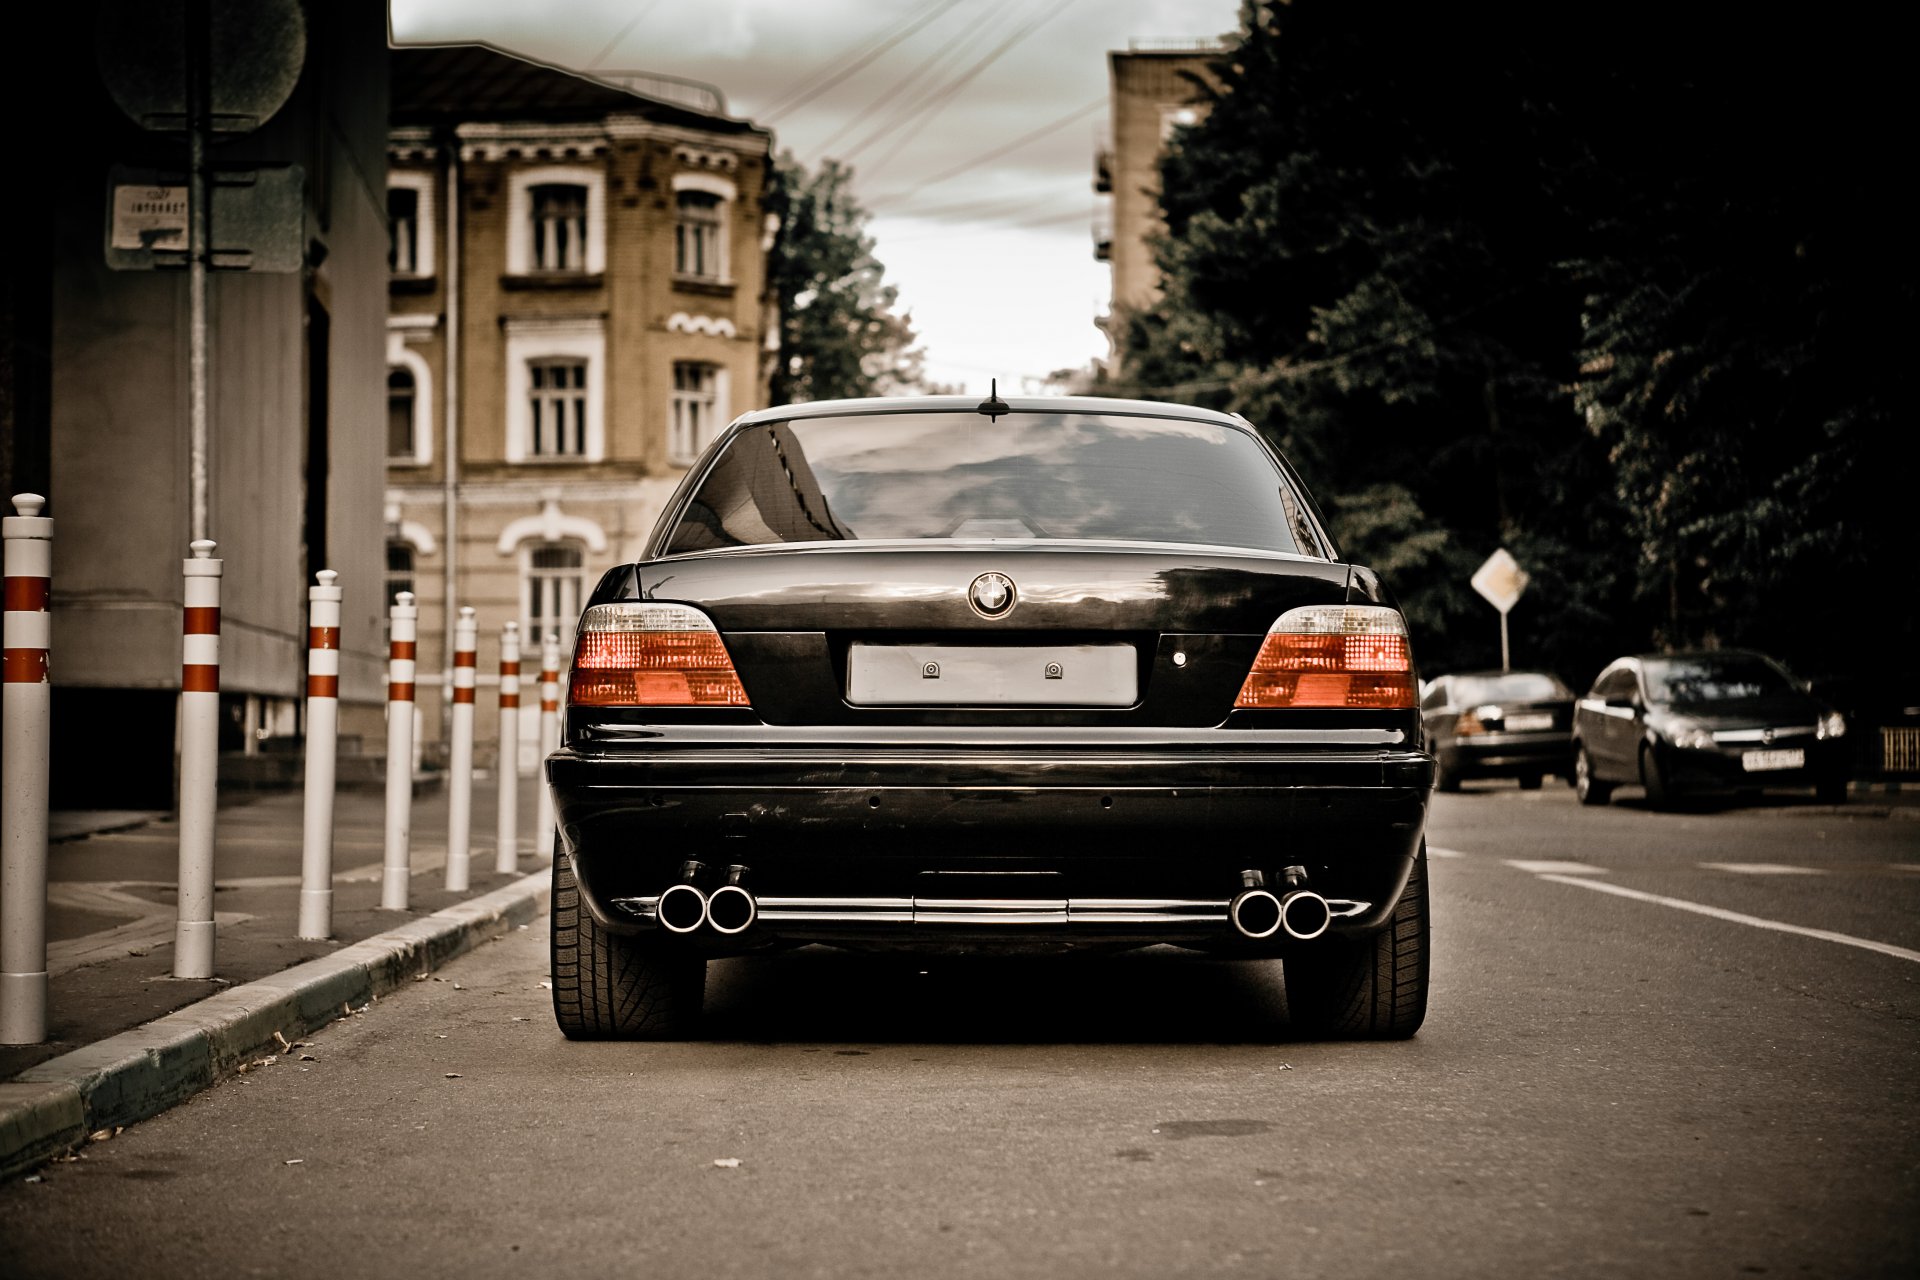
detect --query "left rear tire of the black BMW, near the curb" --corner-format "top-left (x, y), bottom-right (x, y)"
top-left (553, 848), bottom-right (707, 1040)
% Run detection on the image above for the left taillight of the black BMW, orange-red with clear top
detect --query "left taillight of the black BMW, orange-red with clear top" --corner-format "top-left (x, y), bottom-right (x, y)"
top-left (566, 603), bottom-right (749, 706)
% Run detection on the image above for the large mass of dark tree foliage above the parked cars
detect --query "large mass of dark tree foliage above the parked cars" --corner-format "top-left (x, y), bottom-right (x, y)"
top-left (1117, 0), bottom-right (1914, 679)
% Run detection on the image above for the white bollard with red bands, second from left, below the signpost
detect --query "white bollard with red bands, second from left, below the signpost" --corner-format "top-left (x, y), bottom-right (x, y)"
top-left (173, 537), bottom-right (225, 979)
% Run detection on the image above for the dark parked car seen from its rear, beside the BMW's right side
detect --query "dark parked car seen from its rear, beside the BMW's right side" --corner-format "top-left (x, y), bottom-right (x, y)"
top-left (1421, 672), bottom-right (1572, 791)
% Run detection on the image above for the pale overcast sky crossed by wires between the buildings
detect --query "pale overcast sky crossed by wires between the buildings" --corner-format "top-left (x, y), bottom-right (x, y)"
top-left (392, 0), bottom-right (1238, 391)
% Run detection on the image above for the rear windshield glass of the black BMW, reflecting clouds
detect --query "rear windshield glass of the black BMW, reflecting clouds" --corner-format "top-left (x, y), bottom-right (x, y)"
top-left (666, 413), bottom-right (1300, 555)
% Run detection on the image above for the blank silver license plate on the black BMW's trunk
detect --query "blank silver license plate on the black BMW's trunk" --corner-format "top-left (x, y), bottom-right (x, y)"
top-left (847, 645), bottom-right (1140, 706)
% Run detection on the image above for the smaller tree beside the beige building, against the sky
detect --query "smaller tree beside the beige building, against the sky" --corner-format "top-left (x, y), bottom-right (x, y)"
top-left (768, 152), bottom-right (924, 405)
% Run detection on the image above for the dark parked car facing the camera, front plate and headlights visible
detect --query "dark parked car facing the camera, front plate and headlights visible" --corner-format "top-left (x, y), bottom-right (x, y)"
top-left (1572, 649), bottom-right (1849, 806)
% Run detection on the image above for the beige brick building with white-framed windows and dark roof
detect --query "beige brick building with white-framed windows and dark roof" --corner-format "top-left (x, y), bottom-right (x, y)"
top-left (386, 46), bottom-right (778, 766)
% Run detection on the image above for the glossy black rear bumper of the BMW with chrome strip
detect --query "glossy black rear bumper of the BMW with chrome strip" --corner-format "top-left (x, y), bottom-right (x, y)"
top-left (547, 739), bottom-right (1432, 954)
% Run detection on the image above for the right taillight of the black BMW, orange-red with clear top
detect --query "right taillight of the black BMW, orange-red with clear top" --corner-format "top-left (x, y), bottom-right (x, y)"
top-left (1233, 604), bottom-right (1419, 710)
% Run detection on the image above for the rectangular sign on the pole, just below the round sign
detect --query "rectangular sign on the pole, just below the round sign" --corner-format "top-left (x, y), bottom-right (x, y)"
top-left (106, 165), bottom-right (307, 273)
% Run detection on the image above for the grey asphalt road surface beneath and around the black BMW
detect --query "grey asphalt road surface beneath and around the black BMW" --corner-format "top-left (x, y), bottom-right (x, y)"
top-left (0, 787), bottom-right (1920, 1278)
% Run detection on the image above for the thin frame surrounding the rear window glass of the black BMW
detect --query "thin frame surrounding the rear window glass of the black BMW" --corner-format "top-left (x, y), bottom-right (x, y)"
top-left (645, 403), bottom-right (1340, 564)
